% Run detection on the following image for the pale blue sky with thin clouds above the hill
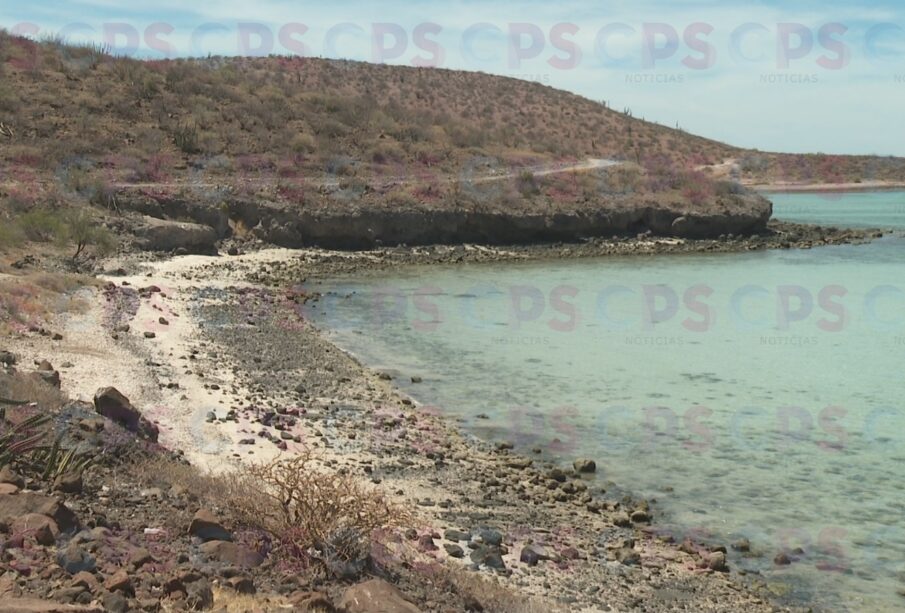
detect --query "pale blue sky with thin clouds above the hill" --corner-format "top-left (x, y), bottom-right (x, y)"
top-left (0, 0), bottom-right (905, 156)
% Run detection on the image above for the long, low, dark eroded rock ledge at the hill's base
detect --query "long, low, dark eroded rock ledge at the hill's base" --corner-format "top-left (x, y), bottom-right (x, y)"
top-left (120, 191), bottom-right (773, 249)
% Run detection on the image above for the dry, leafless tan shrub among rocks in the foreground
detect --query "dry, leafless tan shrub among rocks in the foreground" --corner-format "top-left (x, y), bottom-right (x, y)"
top-left (225, 451), bottom-right (410, 574)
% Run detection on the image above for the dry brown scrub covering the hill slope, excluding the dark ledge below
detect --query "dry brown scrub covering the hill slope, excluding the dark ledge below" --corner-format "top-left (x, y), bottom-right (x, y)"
top-left (0, 32), bottom-right (905, 220)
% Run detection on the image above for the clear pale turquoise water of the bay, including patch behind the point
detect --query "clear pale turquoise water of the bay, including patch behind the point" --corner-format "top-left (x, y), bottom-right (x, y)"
top-left (311, 192), bottom-right (905, 611)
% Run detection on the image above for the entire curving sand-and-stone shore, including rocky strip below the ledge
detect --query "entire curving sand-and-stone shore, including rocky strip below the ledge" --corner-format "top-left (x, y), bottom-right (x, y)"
top-left (3, 230), bottom-right (873, 611)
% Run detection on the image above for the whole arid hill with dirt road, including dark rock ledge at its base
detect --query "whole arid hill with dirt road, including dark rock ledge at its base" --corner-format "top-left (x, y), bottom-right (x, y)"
top-left (0, 34), bottom-right (905, 246)
